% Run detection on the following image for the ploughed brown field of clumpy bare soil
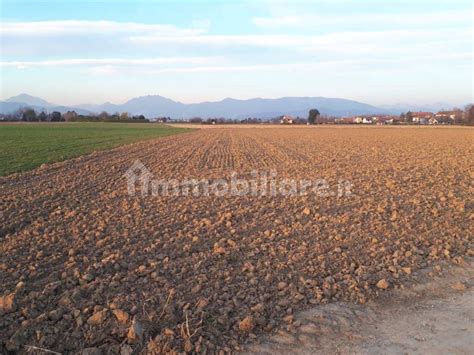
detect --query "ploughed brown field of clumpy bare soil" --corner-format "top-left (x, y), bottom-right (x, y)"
top-left (0, 126), bottom-right (474, 353)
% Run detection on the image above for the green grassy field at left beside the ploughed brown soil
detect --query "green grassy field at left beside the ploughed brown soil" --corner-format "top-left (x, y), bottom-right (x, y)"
top-left (0, 123), bottom-right (193, 176)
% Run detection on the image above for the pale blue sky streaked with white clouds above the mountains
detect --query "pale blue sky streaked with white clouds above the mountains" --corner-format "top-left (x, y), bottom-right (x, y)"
top-left (0, 0), bottom-right (474, 106)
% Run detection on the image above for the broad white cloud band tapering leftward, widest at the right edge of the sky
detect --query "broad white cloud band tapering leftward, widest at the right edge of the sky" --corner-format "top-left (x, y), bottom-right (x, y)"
top-left (128, 28), bottom-right (472, 55)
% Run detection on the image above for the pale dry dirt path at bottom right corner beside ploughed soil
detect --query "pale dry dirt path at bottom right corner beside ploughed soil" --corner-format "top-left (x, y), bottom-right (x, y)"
top-left (246, 260), bottom-right (474, 355)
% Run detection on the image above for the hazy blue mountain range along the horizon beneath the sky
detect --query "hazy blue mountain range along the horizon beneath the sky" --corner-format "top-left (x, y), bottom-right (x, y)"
top-left (0, 94), bottom-right (460, 119)
